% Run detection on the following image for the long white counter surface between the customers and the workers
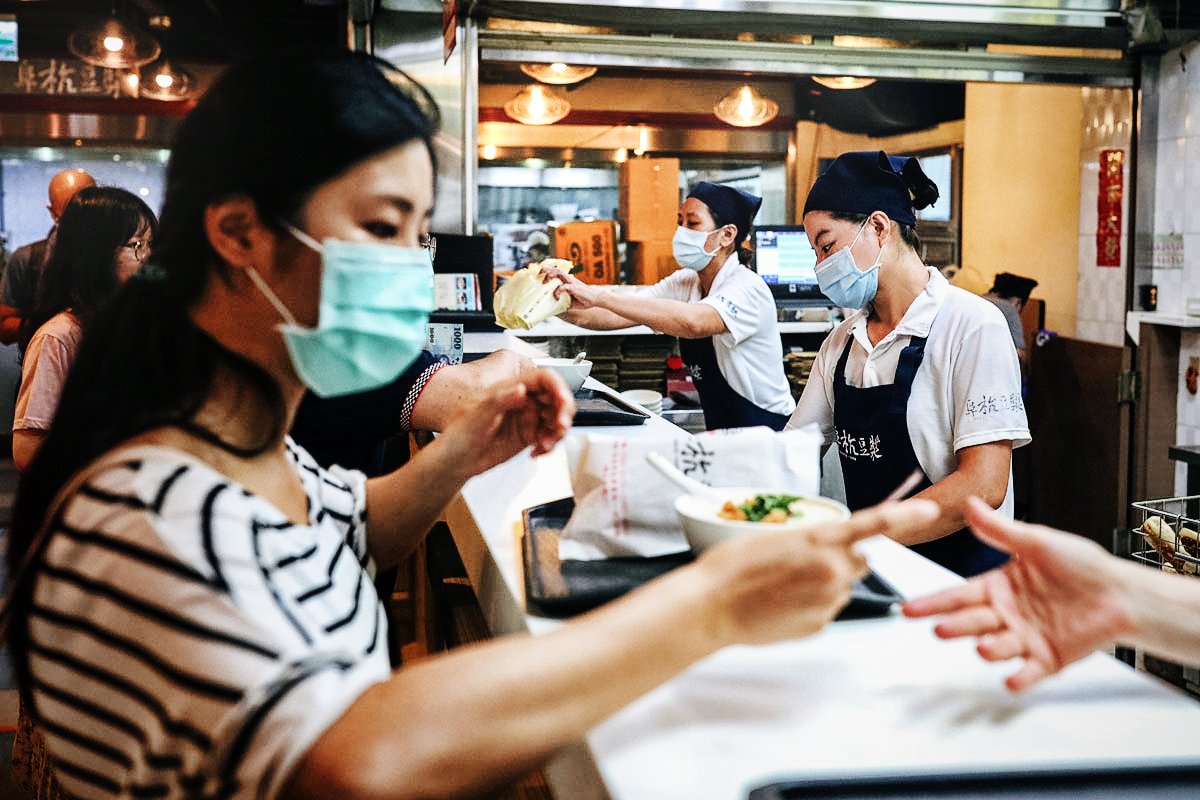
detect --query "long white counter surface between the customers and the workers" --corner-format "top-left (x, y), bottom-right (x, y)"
top-left (448, 333), bottom-right (1200, 800)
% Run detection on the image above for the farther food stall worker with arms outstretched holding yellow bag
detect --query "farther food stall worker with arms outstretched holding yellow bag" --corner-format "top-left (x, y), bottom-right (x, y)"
top-left (545, 181), bottom-right (796, 431)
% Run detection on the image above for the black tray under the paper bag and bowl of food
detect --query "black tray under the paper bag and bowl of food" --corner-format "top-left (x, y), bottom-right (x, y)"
top-left (521, 498), bottom-right (902, 620)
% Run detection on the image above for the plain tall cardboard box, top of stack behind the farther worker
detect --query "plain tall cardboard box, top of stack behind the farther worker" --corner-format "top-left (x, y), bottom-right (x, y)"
top-left (617, 158), bottom-right (680, 242)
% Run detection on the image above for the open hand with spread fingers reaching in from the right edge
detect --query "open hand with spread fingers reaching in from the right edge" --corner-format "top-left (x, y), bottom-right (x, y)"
top-left (904, 498), bottom-right (1133, 692)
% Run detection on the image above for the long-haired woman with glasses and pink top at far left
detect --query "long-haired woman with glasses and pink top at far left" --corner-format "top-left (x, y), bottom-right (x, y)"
top-left (12, 186), bottom-right (158, 470)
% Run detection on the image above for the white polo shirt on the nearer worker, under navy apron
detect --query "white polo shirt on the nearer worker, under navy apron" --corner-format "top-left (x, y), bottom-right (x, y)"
top-left (787, 267), bottom-right (1030, 516)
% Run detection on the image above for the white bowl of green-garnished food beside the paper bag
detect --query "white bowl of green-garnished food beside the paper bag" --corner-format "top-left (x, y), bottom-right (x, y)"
top-left (676, 487), bottom-right (850, 553)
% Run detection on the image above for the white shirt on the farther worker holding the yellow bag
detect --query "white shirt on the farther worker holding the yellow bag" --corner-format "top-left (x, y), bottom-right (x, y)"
top-left (638, 253), bottom-right (796, 414)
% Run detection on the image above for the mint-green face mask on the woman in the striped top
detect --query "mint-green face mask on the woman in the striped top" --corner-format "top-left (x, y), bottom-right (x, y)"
top-left (248, 222), bottom-right (433, 397)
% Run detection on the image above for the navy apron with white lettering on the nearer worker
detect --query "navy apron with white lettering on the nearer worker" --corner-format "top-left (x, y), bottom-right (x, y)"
top-left (833, 337), bottom-right (1008, 577)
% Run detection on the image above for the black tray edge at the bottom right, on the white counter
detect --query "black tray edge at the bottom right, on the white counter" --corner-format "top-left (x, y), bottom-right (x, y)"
top-left (750, 764), bottom-right (1200, 800)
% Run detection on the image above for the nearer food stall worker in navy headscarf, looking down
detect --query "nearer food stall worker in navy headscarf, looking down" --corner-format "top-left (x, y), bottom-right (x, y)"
top-left (788, 151), bottom-right (1030, 576)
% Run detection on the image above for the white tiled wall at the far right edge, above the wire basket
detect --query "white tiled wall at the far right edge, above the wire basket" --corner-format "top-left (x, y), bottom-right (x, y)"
top-left (1152, 43), bottom-right (1200, 494)
